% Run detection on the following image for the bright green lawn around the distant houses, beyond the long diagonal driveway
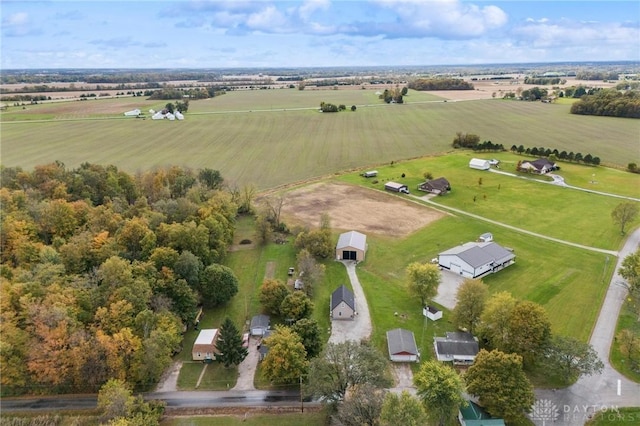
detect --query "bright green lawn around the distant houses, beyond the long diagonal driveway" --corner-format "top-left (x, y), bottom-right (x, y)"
top-left (339, 151), bottom-right (640, 250)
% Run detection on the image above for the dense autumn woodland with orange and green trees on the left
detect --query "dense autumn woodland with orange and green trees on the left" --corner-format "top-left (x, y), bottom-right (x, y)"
top-left (0, 162), bottom-right (243, 395)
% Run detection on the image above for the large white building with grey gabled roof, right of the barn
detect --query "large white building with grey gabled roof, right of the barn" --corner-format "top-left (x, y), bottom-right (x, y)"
top-left (438, 242), bottom-right (516, 278)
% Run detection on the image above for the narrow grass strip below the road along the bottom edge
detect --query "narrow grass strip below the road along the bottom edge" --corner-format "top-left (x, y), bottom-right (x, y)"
top-left (160, 410), bottom-right (328, 426)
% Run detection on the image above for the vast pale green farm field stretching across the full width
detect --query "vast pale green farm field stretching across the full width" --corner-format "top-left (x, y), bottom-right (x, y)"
top-left (0, 89), bottom-right (640, 189)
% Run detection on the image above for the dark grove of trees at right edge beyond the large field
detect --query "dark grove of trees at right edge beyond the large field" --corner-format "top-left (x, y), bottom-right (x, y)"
top-left (571, 89), bottom-right (640, 118)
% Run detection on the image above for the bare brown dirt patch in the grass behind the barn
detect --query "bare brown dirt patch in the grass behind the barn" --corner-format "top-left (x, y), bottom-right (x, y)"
top-left (282, 183), bottom-right (443, 237)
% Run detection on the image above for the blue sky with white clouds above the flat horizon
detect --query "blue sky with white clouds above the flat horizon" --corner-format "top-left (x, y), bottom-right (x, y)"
top-left (0, 0), bottom-right (640, 69)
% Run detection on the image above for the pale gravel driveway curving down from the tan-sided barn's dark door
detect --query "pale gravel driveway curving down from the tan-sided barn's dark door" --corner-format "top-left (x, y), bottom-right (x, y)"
top-left (329, 260), bottom-right (372, 343)
